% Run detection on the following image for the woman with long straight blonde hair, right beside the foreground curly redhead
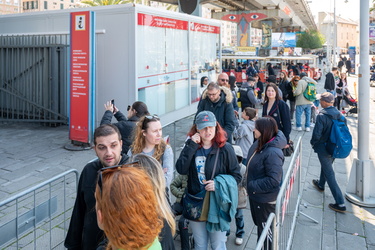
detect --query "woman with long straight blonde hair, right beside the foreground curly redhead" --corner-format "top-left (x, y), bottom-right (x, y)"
top-left (130, 154), bottom-right (176, 250)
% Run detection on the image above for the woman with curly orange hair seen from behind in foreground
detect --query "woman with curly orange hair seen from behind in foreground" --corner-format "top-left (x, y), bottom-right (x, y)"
top-left (95, 164), bottom-right (163, 250)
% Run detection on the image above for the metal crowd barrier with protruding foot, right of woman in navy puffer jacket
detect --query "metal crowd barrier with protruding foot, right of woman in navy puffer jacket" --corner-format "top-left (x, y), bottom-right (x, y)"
top-left (273, 137), bottom-right (318, 250)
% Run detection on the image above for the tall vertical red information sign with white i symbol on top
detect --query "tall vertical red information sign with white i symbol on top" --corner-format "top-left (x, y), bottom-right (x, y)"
top-left (69, 11), bottom-right (91, 143)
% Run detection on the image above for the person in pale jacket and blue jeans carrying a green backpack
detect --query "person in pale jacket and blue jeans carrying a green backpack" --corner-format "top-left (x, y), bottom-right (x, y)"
top-left (293, 72), bottom-right (316, 132)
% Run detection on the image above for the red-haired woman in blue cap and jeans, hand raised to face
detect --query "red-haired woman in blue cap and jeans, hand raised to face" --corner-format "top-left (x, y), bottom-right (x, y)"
top-left (176, 111), bottom-right (241, 250)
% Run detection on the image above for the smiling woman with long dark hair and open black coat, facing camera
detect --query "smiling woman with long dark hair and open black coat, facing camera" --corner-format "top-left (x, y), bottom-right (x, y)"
top-left (262, 83), bottom-right (292, 142)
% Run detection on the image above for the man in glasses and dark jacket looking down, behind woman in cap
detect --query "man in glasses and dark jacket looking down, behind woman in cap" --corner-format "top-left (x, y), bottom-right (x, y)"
top-left (194, 81), bottom-right (236, 142)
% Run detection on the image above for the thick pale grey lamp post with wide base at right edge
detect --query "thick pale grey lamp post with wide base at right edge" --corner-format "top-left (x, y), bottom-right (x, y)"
top-left (345, 0), bottom-right (375, 207)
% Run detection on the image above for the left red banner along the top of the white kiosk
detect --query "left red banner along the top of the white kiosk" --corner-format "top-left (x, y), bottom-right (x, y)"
top-left (138, 13), bottom-right (188, 30)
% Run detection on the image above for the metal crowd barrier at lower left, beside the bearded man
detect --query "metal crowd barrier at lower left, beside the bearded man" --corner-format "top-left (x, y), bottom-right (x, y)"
top-left (0, 169), bottom-right (79, 249)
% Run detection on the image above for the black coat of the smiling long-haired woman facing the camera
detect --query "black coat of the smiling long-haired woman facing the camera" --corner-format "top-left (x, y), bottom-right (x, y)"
top-left (262, 100), bottom-right (292, 142)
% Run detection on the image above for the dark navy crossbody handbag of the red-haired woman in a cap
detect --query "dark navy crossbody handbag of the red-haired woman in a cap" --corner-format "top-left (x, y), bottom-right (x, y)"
top-left (182, 148), bottom-right (220, 221)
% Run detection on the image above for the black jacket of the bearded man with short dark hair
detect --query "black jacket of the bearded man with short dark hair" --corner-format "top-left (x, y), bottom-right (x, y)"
top-left (64, 154), bottom-right (129, 250)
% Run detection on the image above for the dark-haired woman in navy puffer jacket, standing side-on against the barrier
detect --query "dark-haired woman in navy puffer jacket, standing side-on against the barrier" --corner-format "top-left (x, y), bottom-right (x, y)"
top-left (247, 117), bottom-right (286, 249)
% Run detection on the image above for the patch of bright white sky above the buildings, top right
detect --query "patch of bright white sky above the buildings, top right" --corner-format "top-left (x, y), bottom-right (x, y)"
top-left (307, 0), bottom-right (364, 21)
